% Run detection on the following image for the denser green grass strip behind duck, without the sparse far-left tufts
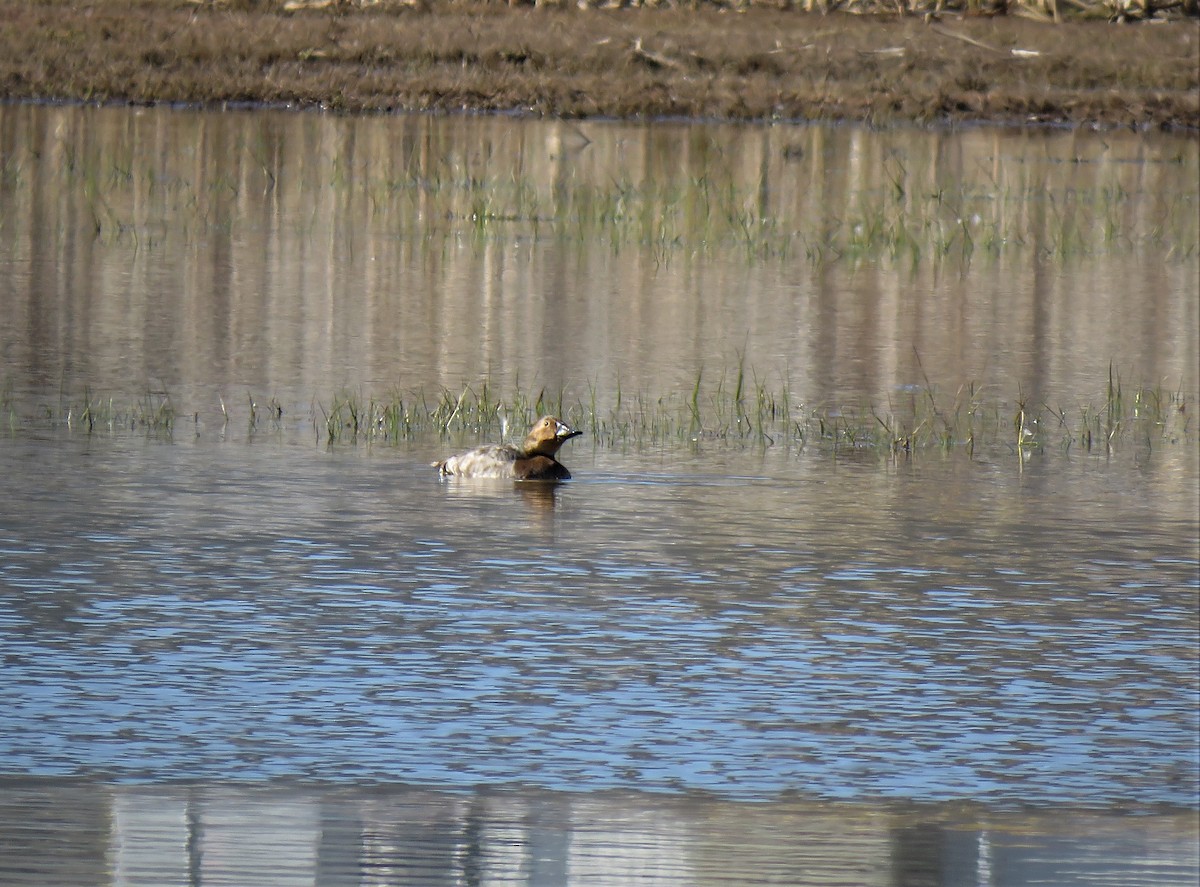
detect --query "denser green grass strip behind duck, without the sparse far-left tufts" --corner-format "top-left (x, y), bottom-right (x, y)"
top-left (302, 361), bottom-right (1196, 457)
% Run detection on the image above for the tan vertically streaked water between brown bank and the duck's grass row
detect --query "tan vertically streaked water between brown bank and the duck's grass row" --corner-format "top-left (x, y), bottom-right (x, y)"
top-left (0, 106), bottom-right (1200, 420)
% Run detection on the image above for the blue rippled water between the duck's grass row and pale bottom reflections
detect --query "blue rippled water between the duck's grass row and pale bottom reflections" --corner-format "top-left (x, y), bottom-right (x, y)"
top-left (0, 439), bottom-right (1200, 807)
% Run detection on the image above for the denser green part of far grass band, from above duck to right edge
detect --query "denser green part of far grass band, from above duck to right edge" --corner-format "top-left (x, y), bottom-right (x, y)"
top-left (390, 164), bottom-right (1195, 268)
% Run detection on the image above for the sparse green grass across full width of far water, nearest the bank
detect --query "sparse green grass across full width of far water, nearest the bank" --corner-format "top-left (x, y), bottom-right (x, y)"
top-left (11, 100), bottom-right (1200, 266)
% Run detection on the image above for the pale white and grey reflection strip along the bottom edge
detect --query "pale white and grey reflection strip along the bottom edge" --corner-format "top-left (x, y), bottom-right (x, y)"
top-left (0, 781), bottom-right (1200, 887)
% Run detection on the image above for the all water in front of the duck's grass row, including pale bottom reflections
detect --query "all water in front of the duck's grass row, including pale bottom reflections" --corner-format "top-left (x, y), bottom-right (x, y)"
top-left (0, 439), bottom-right (1200, 885)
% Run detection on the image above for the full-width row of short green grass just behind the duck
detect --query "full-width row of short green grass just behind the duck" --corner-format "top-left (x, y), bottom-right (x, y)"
top-left (7, 367), bottom-right (1198, 459)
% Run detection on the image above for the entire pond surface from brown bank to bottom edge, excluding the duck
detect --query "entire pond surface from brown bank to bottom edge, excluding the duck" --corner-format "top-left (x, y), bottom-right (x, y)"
top-left (0, 106), bottom-right (1200, 885)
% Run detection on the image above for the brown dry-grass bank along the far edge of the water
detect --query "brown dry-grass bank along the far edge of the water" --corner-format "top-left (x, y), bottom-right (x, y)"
top-left (0, 0), bottom-right (1200, 128)
